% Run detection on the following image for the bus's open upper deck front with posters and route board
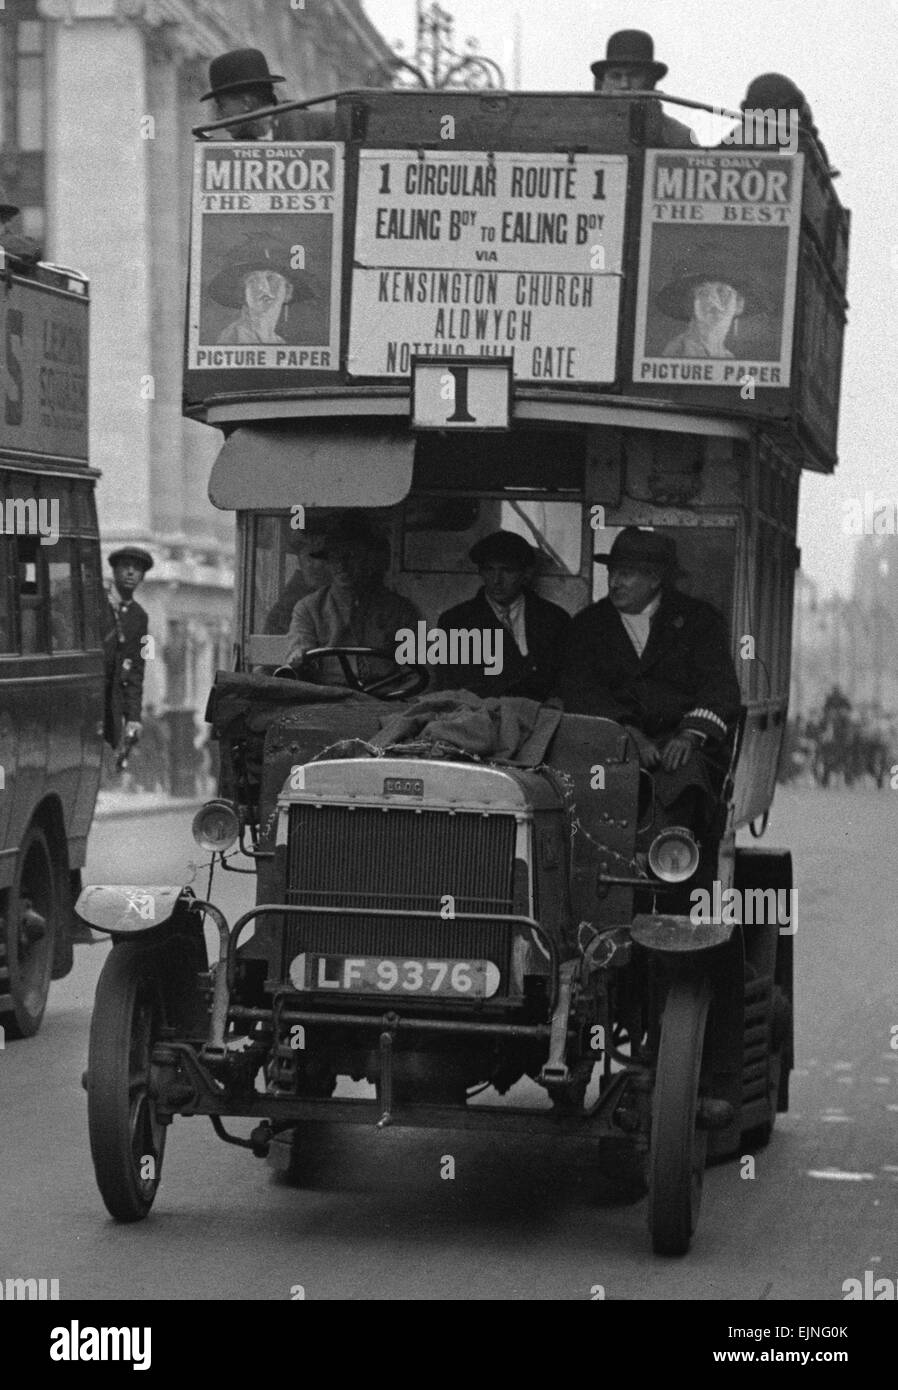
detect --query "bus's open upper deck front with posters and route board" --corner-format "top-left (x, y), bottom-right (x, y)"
top-left (185, 90), bottom-right (848, 471)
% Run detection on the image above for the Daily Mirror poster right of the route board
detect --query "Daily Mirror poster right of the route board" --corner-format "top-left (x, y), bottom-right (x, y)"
top-left (632, 150), bottom-right (803, 389)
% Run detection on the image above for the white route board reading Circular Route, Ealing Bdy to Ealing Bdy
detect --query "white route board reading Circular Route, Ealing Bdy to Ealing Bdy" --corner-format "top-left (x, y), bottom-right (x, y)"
top-left (349, 150), bottom-right (627, 384)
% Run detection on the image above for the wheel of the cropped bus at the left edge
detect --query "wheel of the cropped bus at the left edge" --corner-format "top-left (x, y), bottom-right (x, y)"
top-left (0, 826), bottom-right (61, 1038)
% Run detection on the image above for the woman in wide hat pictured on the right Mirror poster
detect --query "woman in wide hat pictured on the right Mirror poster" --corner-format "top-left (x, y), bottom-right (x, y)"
top-left (655, 259), bottom-right (762, 357)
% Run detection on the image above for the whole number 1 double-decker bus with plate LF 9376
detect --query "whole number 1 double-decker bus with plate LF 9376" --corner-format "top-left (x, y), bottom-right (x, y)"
top-left (79, 70), bottom-right (848, 1254)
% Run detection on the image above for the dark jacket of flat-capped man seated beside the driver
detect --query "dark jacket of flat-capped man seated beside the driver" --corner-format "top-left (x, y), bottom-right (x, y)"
top-left (435, 588), bottom-right (570, 701)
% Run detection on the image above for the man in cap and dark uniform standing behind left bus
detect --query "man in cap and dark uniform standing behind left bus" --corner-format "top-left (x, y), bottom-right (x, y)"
top-left (103, 545), bottom-right (153, 751)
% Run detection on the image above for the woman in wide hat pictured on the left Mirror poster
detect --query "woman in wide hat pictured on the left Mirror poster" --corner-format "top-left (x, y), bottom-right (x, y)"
top-left (207, 236), bottom-right (313, 345)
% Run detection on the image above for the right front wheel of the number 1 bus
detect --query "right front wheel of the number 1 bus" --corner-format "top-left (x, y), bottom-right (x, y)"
top-left (648, 980), bottom-right (710, 1255)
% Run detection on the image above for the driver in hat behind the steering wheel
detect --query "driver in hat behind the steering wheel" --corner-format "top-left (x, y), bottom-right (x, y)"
top-left (286, 513), bottom-right (421, 685)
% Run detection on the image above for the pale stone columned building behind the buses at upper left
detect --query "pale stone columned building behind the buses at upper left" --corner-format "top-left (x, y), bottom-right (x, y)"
top-left (14, 0), bottom-right (392, 750)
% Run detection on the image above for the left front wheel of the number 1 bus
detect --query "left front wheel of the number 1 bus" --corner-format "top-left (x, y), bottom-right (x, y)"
top-left (88, 941), bottom-right (165, 1222)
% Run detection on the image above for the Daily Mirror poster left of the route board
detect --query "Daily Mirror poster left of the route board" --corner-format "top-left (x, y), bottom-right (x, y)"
top-left (188, 142), bottom-right (343, 373)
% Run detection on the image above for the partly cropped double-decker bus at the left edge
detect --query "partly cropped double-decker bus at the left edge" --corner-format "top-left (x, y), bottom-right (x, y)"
top-left (0, 257), bottom-right (103, 1038)
